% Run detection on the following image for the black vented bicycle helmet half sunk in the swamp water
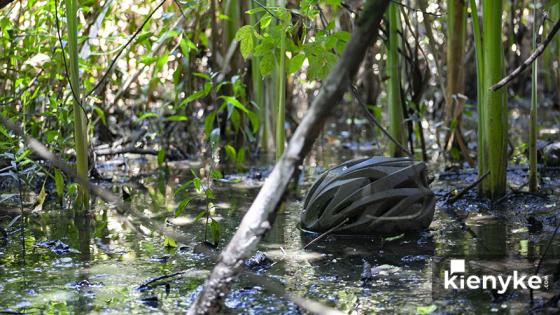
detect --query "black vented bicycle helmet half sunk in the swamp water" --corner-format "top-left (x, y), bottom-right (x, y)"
top-left (301, 157), bottom-right (435, 235)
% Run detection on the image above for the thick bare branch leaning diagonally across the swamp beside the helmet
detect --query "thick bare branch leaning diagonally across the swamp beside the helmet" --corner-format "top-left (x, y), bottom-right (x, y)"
top-left (188, 0), bottom-right (389, 314)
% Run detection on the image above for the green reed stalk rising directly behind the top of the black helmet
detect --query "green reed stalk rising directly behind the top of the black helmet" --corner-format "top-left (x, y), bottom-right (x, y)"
top-left (387, 2), bottom-right (406, 156)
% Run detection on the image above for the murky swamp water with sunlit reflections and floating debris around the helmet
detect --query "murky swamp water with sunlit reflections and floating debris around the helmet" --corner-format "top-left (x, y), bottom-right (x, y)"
top-left (0, 144), bottom-right (560, 314)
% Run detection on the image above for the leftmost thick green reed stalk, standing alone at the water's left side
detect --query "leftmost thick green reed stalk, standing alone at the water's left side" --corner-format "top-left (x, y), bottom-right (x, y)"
top-left (65, 0), bottom-right (89, 206)
